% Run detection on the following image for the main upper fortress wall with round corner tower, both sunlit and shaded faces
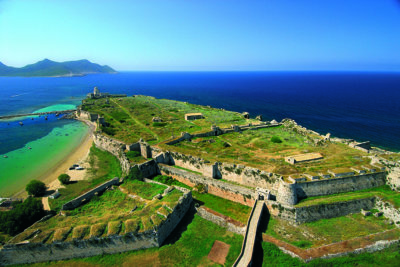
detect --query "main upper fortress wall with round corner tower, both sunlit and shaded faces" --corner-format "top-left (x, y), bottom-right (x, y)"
top-left (149, 147), bottom-right (386, 205)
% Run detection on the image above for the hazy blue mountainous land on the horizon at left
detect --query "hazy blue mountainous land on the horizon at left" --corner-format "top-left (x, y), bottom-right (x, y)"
top-left (0, 59), bottom-right (117, 77)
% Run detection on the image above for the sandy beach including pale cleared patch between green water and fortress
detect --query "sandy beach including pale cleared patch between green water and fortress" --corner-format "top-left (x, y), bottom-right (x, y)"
top-left (13, 121), bottom-right (95, 198)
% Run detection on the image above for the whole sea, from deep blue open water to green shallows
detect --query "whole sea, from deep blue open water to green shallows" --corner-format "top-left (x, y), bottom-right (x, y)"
top-left (0, 72), bottom-right (400, 197)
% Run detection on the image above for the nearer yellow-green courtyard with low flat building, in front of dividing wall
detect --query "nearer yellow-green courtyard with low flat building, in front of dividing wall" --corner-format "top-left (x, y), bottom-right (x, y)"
top-left (165, 126), bottom-right (370, 175)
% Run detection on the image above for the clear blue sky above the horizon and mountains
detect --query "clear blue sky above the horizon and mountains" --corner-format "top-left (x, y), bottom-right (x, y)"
top-left (0, 0), bottom-right (400, 71)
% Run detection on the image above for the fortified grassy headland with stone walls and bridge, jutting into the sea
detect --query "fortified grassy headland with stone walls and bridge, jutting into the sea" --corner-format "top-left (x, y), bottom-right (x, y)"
top-left (0, 87), bottom-right (400, 266)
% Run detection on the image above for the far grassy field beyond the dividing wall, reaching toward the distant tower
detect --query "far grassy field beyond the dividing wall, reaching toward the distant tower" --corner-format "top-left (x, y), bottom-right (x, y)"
top-left (82, 96), bottom-right (253, 144)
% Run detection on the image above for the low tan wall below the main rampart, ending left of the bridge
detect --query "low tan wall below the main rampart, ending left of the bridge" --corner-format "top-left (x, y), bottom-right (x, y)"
top-left (159, 164), bottom-right (257, 206)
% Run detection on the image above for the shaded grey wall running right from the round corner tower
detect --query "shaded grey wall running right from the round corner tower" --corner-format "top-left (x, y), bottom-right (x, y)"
top-left (296, 172), bottom-right (386, 198)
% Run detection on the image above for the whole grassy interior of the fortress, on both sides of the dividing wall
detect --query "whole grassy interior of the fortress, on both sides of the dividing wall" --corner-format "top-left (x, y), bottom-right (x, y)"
top-left (82, 96), bottom-right (370, 178)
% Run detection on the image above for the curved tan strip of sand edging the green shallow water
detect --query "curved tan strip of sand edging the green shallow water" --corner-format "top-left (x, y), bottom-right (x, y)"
top-left (12, 119), bottom-right (95, 198)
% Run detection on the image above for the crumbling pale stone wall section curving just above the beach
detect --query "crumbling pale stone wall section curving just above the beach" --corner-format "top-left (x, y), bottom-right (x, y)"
top-left (93, 133), bottom-right (131, 175)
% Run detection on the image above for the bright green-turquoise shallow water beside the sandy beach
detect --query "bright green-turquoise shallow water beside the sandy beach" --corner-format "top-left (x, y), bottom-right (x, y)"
top-left (0, 120), bottom-right (88, 197)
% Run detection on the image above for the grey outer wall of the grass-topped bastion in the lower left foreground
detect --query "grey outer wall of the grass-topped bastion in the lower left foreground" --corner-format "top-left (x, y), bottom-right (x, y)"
top-left (0, 187), bottom-right (193, 266)
